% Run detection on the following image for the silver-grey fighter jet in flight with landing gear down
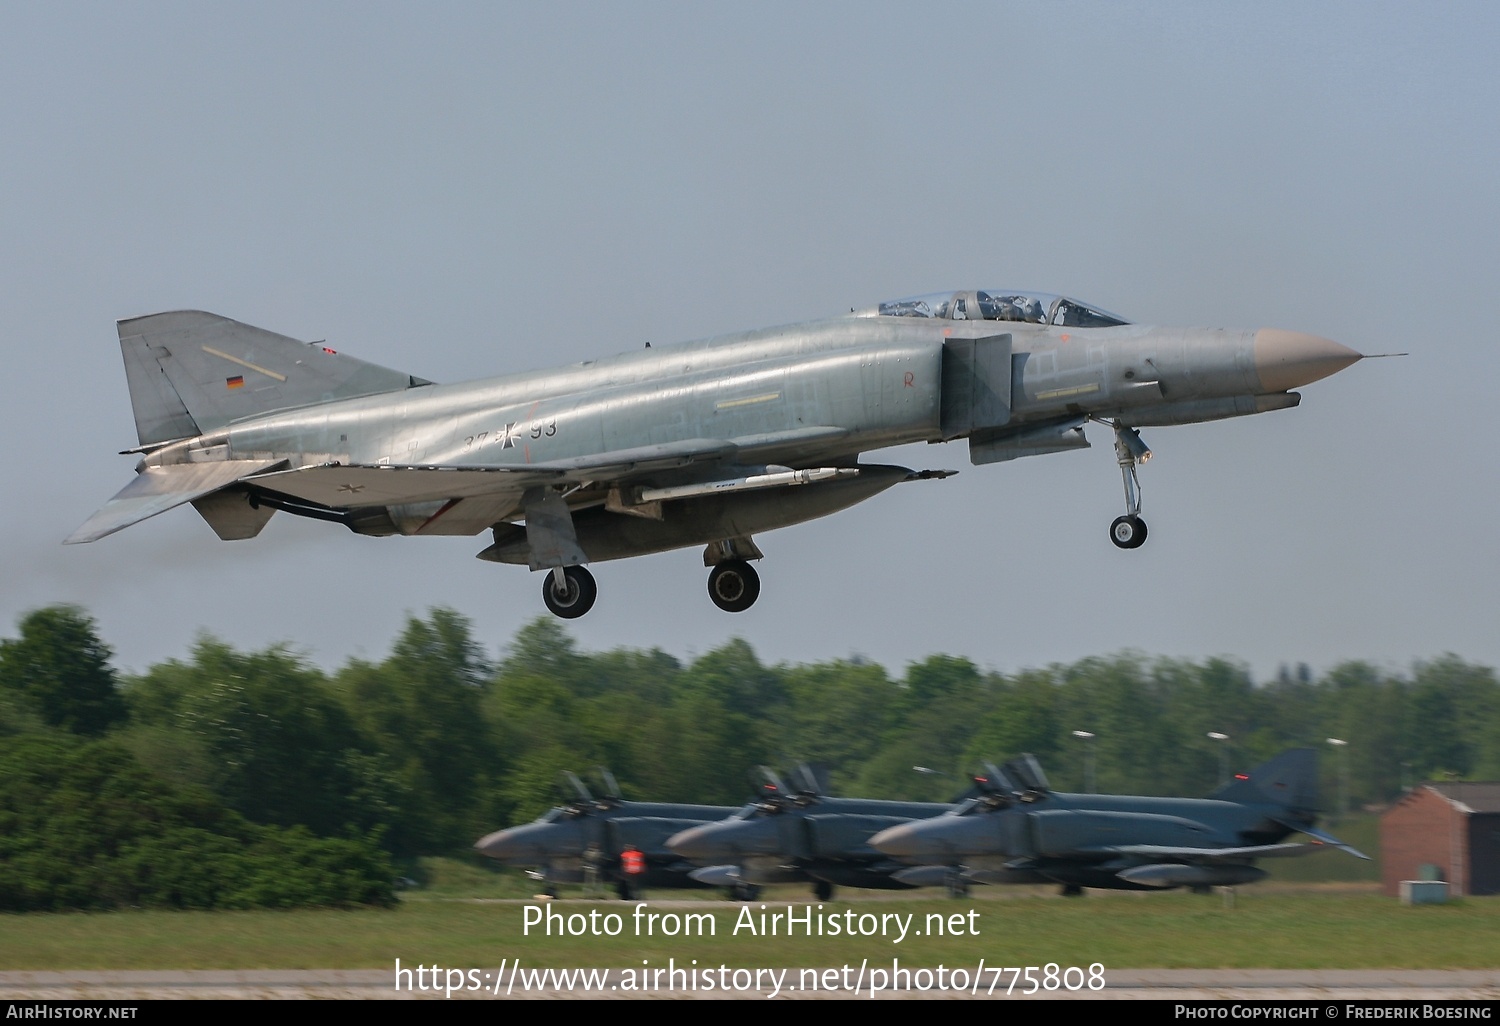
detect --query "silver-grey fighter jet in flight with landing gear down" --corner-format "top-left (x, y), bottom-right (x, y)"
top-left (68, 290), bottom-right (1362, 617)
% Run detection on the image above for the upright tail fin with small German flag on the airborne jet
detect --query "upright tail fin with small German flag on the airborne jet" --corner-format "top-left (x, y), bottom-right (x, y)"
top-left (119, 311), bottom-right (432, 446)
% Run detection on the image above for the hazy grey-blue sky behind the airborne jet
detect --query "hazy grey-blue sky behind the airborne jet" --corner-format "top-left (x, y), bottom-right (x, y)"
top-left (0, 2), bottom-right (1500, 677)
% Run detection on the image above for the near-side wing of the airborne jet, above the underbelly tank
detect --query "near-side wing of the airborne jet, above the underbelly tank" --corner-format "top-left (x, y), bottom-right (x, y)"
top-left (255, 428), bottom-right (848, 507)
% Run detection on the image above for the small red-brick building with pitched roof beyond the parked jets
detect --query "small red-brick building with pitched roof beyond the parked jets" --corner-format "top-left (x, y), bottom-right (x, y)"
top-left (1380, 782), bottom-right (1500, 897)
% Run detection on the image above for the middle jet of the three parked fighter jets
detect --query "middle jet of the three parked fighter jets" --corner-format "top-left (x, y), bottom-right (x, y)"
top-left (666, 767), bottom-right (951, 900)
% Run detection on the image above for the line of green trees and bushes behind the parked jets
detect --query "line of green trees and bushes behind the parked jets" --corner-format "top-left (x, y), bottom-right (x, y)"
top-left (0, 606), bottom-right (1500, 909)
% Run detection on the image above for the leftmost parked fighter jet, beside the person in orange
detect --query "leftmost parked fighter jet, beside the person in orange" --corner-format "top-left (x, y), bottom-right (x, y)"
top-left (474, 771), bottom-right (735, 900)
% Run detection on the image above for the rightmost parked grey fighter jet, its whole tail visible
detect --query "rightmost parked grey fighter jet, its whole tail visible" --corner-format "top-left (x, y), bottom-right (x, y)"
top-left (870, 749), bottom-right (1367, 894)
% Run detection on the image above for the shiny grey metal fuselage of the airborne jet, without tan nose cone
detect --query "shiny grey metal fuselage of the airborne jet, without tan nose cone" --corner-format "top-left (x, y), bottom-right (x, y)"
top-left (208, 317), bottom-right (1295, 467)
